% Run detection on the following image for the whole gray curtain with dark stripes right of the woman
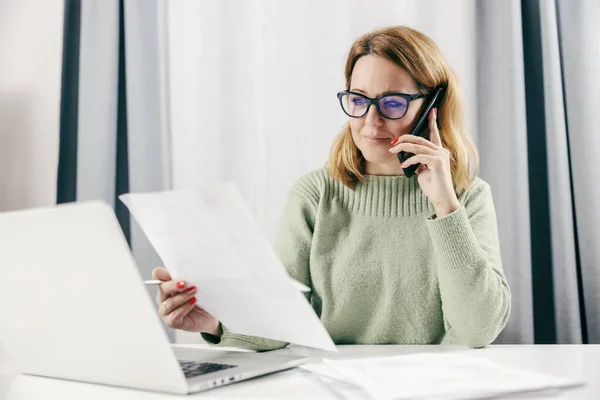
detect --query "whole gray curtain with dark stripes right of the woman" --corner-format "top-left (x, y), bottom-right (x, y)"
top-left (476, 0), bottom-right (600, 343)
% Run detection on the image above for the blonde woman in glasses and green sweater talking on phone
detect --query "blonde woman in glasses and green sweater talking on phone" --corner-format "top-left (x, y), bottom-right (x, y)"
top-left (153, 27), bottom-right (511, 350)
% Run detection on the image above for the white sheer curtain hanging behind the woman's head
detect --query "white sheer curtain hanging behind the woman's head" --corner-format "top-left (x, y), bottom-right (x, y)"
top-left (167, 0), bottom-right (477, 245)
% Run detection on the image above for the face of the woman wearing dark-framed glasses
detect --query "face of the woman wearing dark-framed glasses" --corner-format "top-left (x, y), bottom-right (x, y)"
top-left (350, 55), bottom-right (423, 175)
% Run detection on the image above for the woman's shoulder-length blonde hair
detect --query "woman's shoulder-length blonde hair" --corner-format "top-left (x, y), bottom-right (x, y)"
top-left (328, 26), bottom-right (479, 193)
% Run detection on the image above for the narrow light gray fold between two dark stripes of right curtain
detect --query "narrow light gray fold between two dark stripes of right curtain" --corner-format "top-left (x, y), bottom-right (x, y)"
top-left (534, 1), bottom-right (586, 343)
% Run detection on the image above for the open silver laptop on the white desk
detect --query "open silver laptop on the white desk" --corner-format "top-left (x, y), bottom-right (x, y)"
top-left (0, 201), bottom-right (306, 394)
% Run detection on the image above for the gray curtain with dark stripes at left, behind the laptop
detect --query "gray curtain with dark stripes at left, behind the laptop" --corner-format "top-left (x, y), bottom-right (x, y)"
top-left (57, 0), bottom-right (171, 333)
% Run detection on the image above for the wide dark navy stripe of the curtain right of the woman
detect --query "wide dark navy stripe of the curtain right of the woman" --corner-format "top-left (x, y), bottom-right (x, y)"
top-left (521, 0), bottom-right (564, 344)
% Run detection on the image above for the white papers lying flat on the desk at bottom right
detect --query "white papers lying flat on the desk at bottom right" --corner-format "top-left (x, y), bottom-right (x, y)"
top-left (312, 353), bottom-right (582, 400)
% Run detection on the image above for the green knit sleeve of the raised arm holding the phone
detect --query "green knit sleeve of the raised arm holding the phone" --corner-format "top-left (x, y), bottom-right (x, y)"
top-left (427, 179), bottom-right (511, 347)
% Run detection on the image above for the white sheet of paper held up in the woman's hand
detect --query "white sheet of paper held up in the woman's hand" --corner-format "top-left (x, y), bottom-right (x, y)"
top-left (119, 183), bottom-right (336, 351)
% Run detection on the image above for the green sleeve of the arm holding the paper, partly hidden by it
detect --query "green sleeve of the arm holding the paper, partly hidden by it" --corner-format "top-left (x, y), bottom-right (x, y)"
top-left (201, 180), bottom-right (318, 351)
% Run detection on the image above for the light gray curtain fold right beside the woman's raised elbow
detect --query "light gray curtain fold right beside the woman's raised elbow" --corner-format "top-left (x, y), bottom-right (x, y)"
top-left (476, 0), bottom-right (534, 343)
